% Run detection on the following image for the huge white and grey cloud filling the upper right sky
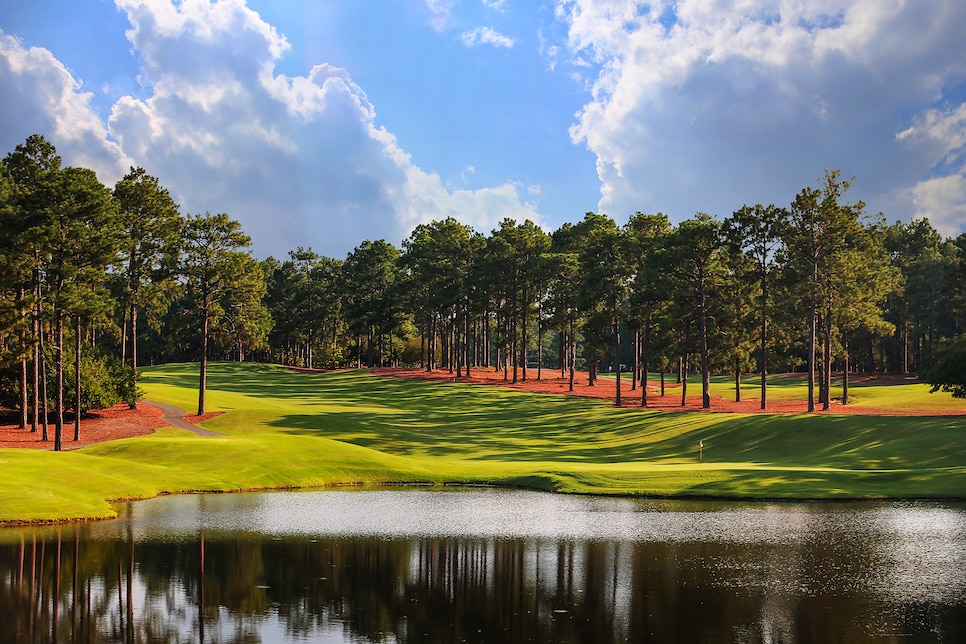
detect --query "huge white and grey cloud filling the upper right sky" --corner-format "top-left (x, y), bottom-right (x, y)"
top-left (555, 0), bottom-right (966, 231)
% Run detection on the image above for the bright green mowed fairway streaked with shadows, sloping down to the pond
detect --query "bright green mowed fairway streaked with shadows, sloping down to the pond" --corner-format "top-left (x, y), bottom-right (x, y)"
top-left (0, 363), bottom-right (966, 522)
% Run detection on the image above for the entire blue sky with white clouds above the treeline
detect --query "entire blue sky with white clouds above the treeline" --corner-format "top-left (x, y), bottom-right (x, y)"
top-left (0, 0), bottom-right (966, 258)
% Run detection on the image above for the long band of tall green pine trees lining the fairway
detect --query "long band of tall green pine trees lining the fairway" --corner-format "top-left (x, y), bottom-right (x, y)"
top-left (0, 135), bottom-right (966, 449)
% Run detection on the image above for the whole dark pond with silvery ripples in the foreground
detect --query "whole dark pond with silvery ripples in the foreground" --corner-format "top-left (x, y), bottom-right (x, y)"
top-left (0, 489), bottom-right (966, 643)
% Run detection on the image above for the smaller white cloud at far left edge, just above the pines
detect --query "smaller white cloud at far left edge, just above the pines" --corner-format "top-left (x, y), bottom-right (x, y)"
top-left (0, 30), bottom-right (130, 183)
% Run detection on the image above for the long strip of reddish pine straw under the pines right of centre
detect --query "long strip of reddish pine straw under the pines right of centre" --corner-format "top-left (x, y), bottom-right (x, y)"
top-left (372, 367), bottom-right (966, 416)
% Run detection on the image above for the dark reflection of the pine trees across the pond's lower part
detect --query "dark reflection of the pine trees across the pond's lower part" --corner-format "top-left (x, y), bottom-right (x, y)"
top-left (0, 494), bottom-right (966, 642)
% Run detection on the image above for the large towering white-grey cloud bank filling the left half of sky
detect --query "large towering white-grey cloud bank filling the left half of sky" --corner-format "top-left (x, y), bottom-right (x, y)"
top-left (0, 0), bottom-right (541, 256)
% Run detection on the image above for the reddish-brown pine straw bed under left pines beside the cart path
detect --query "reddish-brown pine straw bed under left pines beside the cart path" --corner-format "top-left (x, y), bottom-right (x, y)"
top-left (0, 403), bottom-right (223, 450)
